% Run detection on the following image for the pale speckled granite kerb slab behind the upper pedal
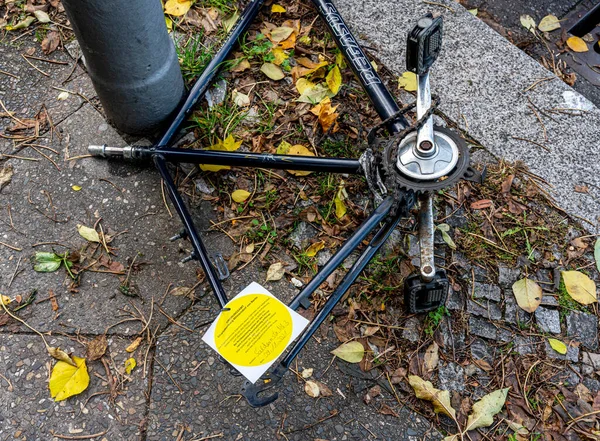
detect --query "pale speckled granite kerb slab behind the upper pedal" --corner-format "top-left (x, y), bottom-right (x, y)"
top-left (336, 0), bottom-right (600, 232)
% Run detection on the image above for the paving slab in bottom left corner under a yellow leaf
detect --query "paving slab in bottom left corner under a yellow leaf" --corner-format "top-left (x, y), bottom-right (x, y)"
top-left (0, 334), bottom-right (148, 441)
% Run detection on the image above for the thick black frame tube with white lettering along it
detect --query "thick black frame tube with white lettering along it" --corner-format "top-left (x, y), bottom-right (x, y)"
top-left (312, 0), bottom-right (408, 132)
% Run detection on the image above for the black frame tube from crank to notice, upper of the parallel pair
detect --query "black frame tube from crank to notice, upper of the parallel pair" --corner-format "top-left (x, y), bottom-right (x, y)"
top-left (289, 196), bottom-right (394, 309)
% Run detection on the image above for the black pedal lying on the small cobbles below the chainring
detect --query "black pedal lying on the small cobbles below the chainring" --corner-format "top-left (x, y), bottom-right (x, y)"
top-left (404, 270), bottom-right (450, 314)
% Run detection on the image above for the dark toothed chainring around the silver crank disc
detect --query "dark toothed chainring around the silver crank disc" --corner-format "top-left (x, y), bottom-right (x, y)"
top-left (376, 126), bottom-right (475, 195)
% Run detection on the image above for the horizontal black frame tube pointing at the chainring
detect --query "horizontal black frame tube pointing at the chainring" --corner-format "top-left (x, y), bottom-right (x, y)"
top-left (152, 147), bottom-right (362, 174)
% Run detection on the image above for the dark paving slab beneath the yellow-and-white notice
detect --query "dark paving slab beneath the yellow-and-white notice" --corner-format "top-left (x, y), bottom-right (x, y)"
top-left (147, 266), bottom-right (441, 441)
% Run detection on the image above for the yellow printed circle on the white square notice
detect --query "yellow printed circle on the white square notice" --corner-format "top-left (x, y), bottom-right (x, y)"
top-left (214, 293), bottom-right (293, 367)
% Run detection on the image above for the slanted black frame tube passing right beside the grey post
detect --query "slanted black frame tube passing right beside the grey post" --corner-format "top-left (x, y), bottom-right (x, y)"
top-left (158, 0), bottom-right (264, 146)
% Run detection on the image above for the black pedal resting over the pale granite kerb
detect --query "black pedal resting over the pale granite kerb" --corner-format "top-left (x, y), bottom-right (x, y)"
top-left (406, 14), bottom-right (443, 75)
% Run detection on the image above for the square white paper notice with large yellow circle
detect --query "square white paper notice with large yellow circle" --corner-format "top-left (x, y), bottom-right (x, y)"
top-left (202, 282), bottom-right (308, 383)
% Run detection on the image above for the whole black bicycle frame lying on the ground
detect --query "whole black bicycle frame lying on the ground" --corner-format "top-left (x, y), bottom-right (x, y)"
top-left (97, 0), bottom-right (407, 406)
